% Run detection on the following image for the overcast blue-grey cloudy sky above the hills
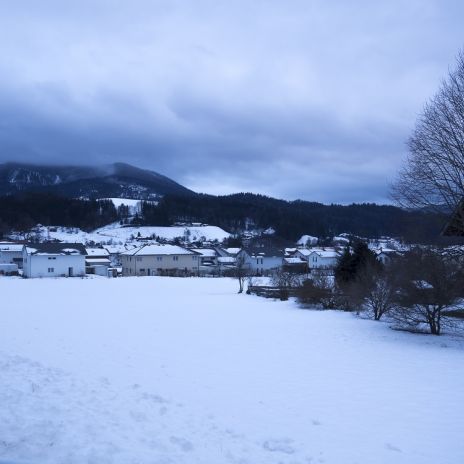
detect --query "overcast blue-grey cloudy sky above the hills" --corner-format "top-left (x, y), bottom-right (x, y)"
top-left (0, 0), bottom-right (464, 203)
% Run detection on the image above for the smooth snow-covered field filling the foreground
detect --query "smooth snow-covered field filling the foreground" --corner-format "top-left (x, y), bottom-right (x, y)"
top-left (0, 277), bottom-right (464, 464)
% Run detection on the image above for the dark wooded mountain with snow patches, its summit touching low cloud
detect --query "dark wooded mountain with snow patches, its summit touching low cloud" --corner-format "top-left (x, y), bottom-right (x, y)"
top-left (0, 163), bottom-right (193, 199)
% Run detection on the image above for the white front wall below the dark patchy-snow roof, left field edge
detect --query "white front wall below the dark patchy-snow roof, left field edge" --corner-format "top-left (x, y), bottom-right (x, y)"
top-left (24, 255), bottom-right (85, 277)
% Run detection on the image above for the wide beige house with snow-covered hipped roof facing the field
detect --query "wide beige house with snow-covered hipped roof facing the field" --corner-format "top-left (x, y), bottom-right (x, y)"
top-left (121, 244), bottom-right (201, 277)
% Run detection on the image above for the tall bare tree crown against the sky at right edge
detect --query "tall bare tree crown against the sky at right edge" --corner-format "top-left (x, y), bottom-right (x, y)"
top-left (392, 50), bottom-right (464, 233)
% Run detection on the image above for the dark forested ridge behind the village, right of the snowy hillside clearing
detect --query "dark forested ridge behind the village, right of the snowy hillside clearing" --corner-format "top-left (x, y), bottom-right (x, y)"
top-left (140, 193), bottom-right (446, 243)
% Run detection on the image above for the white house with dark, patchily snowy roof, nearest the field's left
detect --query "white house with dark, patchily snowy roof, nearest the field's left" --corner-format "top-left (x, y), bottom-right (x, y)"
top-left (23, 243), bottom-right (86, 277)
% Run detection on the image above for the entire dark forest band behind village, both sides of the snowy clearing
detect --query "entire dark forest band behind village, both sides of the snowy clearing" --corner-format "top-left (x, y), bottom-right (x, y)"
top-left (0, 193), bottom-right (445, 242)
